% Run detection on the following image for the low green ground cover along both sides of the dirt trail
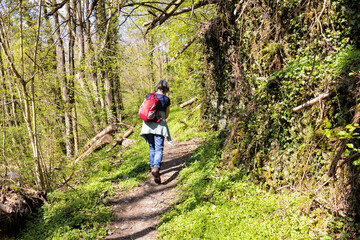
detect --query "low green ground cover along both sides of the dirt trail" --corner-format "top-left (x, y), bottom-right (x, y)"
top-left (18, 96), bottom-right (346, 239)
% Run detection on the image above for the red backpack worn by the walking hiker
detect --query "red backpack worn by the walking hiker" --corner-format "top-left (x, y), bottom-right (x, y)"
top-left (139, 93), bottom-right (162, 123)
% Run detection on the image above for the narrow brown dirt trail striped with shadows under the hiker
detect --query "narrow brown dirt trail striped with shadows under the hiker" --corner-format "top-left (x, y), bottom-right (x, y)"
top-left (105, 140), bottom-right (200, 240)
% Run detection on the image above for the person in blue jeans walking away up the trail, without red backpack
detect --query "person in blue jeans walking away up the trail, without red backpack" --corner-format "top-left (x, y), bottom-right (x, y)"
top-left (140, 80), bottom-right (172, 184)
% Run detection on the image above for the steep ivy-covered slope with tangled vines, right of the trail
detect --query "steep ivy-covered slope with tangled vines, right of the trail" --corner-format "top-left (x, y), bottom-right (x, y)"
top-left (197, 0), bottom-right (360, 238)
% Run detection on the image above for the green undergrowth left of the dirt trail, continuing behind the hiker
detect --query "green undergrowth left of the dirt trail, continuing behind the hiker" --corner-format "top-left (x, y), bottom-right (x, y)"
top-left (15, 104), bottom-right (205, 240)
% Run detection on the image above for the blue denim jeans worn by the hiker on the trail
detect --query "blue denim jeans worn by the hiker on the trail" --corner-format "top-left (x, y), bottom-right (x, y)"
top-left (146, 134), bottom-right (164, 168)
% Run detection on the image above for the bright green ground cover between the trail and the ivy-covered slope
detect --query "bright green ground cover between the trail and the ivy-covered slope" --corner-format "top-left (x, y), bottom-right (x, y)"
top-left (159, 140), bottom-right (318, 239)
